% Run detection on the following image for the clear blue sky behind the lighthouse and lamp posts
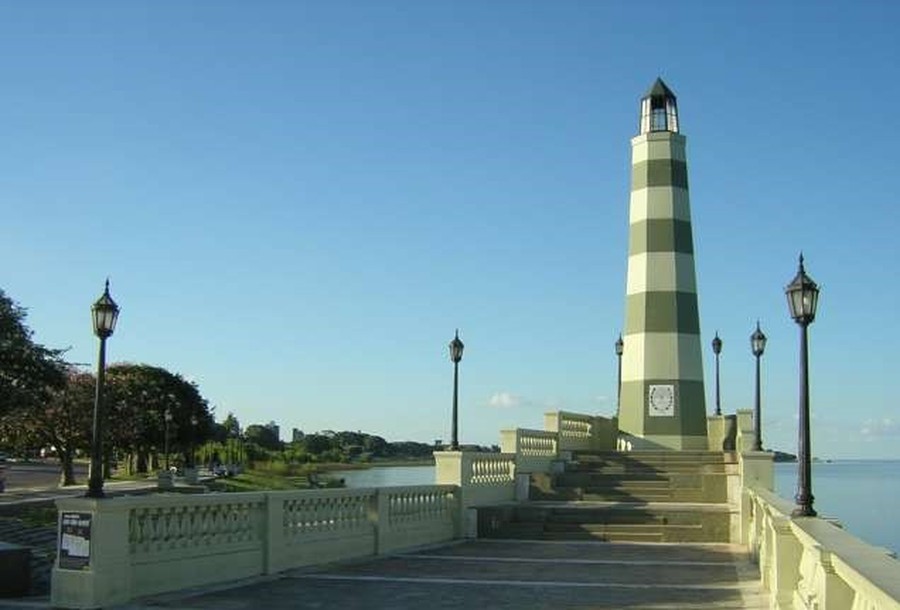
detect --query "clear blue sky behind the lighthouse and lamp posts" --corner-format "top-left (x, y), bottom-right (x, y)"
top-left (0, 0), bottom-right (900, 458)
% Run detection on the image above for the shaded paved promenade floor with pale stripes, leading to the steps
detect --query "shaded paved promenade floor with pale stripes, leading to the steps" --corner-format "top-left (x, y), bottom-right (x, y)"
top-left (51, 540), bottom-right (768, 610)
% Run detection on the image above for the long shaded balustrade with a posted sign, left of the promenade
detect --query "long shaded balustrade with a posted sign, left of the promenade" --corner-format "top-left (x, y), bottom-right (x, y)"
top-left (51, 484), bottom-right (460, 608)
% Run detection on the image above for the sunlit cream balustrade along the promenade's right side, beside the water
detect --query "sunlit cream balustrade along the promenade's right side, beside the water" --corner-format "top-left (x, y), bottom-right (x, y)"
top-left (744, 488), bottom-right (900, 610)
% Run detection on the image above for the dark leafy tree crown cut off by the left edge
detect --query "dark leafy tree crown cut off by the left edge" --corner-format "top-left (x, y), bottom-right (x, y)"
top-left (0, 290), bottom-right (66, 416)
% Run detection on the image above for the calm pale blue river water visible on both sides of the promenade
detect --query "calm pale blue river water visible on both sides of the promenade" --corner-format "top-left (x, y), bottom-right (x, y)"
top-left (330, 460), bottom-right (900, 553)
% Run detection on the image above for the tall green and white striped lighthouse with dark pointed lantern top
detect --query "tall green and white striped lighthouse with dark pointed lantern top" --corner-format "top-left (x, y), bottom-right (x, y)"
top-left (619, 79), bottom-right (707, 450)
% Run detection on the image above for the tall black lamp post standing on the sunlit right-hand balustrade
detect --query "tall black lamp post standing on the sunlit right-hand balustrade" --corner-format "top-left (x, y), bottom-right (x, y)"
top-left (784, 254), bottom-right (819, 517)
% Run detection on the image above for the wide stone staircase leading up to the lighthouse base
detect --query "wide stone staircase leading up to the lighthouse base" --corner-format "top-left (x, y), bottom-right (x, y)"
top-left (478, 451), bottom-right (737, 542)
